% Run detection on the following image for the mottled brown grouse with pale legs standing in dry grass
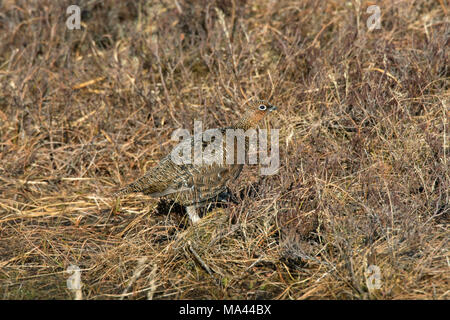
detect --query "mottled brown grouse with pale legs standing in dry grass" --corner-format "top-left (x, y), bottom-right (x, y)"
top-left (114, 100), bottom-right (276, 223)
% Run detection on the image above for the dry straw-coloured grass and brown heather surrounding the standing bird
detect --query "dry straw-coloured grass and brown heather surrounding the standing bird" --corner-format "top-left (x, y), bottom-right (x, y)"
top-left (0, 0), bottom-right (450, 299)
